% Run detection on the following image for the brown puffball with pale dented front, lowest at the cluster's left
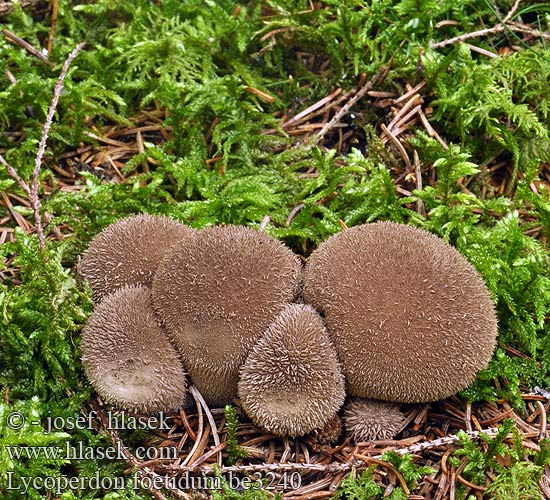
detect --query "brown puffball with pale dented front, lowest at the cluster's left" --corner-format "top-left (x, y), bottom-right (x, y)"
top-left (81, 286), bottom-right (187, 414)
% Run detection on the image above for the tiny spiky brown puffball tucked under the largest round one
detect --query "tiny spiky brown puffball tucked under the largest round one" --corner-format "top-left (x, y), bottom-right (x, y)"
top-left (344, 399), bottom-right (405, 443)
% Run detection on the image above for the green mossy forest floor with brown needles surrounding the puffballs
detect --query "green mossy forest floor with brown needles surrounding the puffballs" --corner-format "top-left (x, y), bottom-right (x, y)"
top-left (0, 0), bottom-right (550, 500)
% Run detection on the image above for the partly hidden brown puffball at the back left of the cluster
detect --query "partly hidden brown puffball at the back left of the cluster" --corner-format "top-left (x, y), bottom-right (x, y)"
top-left (78, 214), bottom-right (193, 300)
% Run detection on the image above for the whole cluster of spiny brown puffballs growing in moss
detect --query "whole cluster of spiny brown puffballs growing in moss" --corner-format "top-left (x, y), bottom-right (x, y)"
top-left (79, 214), bottom-right (497, 441)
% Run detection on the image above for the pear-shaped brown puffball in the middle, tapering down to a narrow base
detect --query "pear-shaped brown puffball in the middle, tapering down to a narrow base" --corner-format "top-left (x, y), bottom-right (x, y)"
top-left (153, 226), bottom-right (302, 404)
